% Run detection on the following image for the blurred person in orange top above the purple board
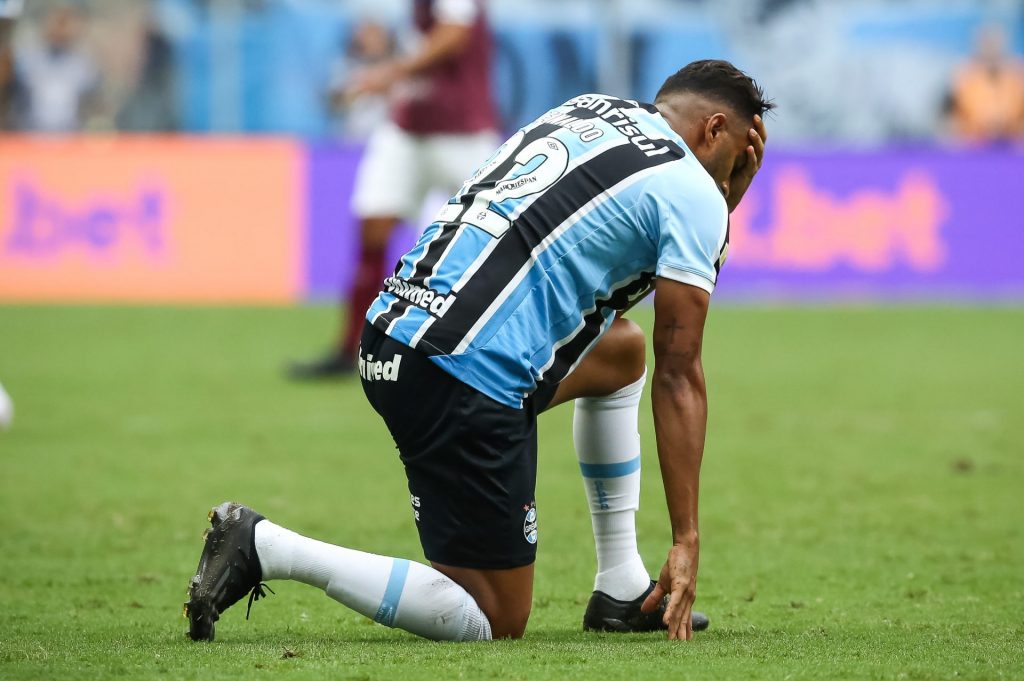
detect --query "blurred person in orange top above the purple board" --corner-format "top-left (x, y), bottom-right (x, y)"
top-left (949, 26), bottom-right (1024, 142)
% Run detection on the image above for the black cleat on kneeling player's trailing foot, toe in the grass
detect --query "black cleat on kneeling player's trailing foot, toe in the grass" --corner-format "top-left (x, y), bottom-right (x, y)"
top-left (184, 502), bottom-right (273, 641)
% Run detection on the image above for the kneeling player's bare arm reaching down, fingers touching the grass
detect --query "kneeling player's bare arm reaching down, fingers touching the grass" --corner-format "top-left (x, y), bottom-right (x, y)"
top-left (644, 279), bottom-right (711, 640)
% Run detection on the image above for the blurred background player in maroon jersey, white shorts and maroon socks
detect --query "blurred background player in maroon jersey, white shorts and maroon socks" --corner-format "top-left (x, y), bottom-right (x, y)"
top-left (289, 0), bottom-right (499, 379)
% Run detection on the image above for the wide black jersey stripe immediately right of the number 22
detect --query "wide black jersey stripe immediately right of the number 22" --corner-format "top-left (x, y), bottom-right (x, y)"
top-left (420, 139), bottom-right (683, 354)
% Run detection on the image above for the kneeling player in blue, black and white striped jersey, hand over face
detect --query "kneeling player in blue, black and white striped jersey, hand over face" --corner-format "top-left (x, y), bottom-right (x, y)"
top-left (186, 60), bottom-right (772, 641)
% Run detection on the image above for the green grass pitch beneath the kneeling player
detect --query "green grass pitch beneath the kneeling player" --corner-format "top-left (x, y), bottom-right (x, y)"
top-left (0, 307), bottom-right (1024, 681)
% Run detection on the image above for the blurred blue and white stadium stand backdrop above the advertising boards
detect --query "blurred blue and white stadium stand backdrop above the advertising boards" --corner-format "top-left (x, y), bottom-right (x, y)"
top-left (4, 0), bottom-right (1024, 140)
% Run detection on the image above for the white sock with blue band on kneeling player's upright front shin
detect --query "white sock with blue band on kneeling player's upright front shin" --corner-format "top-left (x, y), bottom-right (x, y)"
top-left (572, 372), bottom-right (650, 600)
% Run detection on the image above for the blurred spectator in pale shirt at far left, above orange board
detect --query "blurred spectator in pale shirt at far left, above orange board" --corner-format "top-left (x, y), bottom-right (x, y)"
top-left (8, 3), bottom-right (99, 132)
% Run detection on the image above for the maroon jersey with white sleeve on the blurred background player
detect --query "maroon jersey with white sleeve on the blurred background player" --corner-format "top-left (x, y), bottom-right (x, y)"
top-left (392, 0), bottom-right (498, 135)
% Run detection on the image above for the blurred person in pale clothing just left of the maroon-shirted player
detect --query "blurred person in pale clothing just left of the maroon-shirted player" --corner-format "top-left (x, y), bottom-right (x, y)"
top-left (331, 22), bottom-right (394, 142)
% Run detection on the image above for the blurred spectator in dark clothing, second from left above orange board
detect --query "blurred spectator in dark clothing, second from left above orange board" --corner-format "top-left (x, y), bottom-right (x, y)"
top-left (115, 15), bottom-right (178, 132)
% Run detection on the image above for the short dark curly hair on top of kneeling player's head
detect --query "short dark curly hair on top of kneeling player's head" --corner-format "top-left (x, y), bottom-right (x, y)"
top-left (654, 59), bottom-right (775, 118)
